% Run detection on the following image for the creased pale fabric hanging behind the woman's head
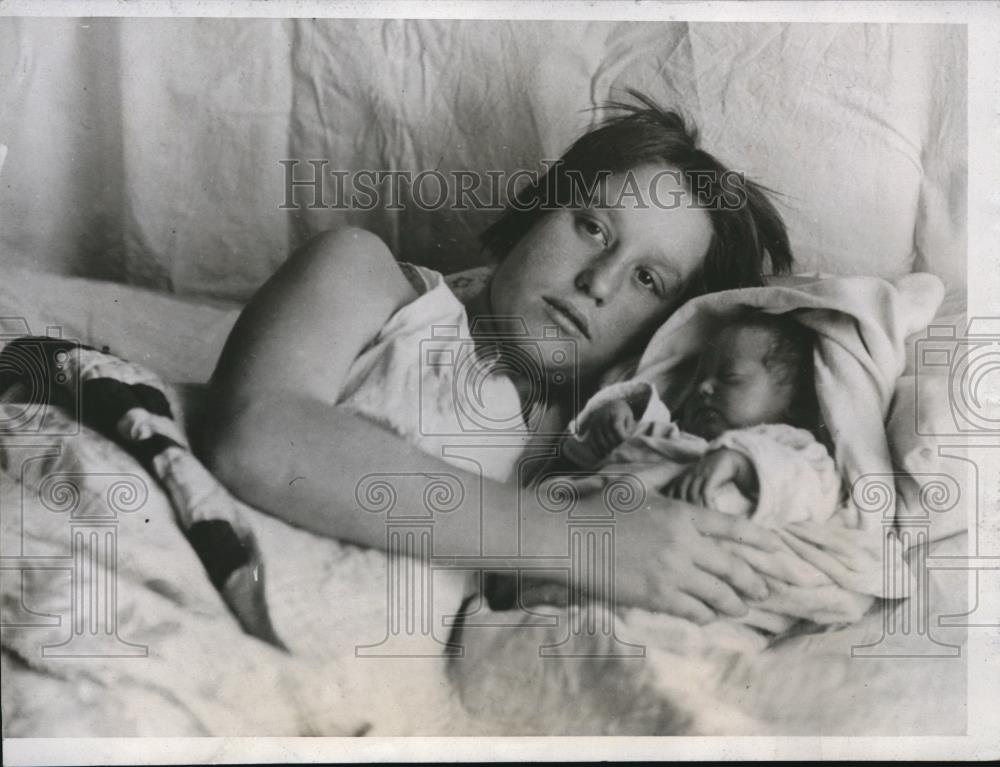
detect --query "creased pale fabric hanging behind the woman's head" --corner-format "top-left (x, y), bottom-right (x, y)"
top-left (0, 18), bottom-right (967, 300)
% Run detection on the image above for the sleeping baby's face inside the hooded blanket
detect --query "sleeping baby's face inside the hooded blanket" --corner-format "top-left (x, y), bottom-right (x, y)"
top-left (679, 325), bottom-right (795, 439)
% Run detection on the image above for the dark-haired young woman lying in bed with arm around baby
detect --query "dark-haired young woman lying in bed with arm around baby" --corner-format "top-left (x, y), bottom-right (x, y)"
top-left (204, 94), bottom-right (791, 622)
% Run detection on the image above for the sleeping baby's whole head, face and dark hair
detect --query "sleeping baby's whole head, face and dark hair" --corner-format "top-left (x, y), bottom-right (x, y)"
top-left (679, 312), bottom-right (818, 439)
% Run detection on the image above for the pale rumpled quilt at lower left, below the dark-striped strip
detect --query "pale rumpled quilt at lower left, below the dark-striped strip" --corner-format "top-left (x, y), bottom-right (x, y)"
top-left (0, 404), bottom-right (369, 737)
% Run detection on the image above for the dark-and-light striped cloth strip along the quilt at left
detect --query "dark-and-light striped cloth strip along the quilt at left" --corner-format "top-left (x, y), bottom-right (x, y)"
top-left (0, 336), bottom-right (282, 647)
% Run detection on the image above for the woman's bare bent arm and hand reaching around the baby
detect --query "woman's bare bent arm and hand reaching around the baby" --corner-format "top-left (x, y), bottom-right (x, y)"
top-left (202, 229), bottom-right (770, 620)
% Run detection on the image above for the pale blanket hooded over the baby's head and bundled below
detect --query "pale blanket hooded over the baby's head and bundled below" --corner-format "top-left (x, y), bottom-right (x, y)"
top-left (608, 274), bottom-right (944, 626)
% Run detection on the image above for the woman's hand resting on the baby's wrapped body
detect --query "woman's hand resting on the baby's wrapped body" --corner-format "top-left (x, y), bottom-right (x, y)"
top-left (615, 496), bottom-right (781, 623)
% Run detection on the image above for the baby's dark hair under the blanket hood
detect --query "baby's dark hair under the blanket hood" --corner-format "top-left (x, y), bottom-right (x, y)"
top-left (733, 311), bottom-right (826, 442)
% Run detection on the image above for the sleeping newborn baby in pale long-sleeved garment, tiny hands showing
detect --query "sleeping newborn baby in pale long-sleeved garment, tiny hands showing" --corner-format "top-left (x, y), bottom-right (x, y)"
top-left (563, 312), bottom-right (840, 527)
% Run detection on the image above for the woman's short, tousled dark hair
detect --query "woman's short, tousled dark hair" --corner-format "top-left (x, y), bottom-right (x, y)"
top-left (481, 90), bottom-right (792, 297)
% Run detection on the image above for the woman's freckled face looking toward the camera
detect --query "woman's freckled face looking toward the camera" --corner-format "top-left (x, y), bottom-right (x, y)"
top-left (489, 166), bottom-right (712, 388)
